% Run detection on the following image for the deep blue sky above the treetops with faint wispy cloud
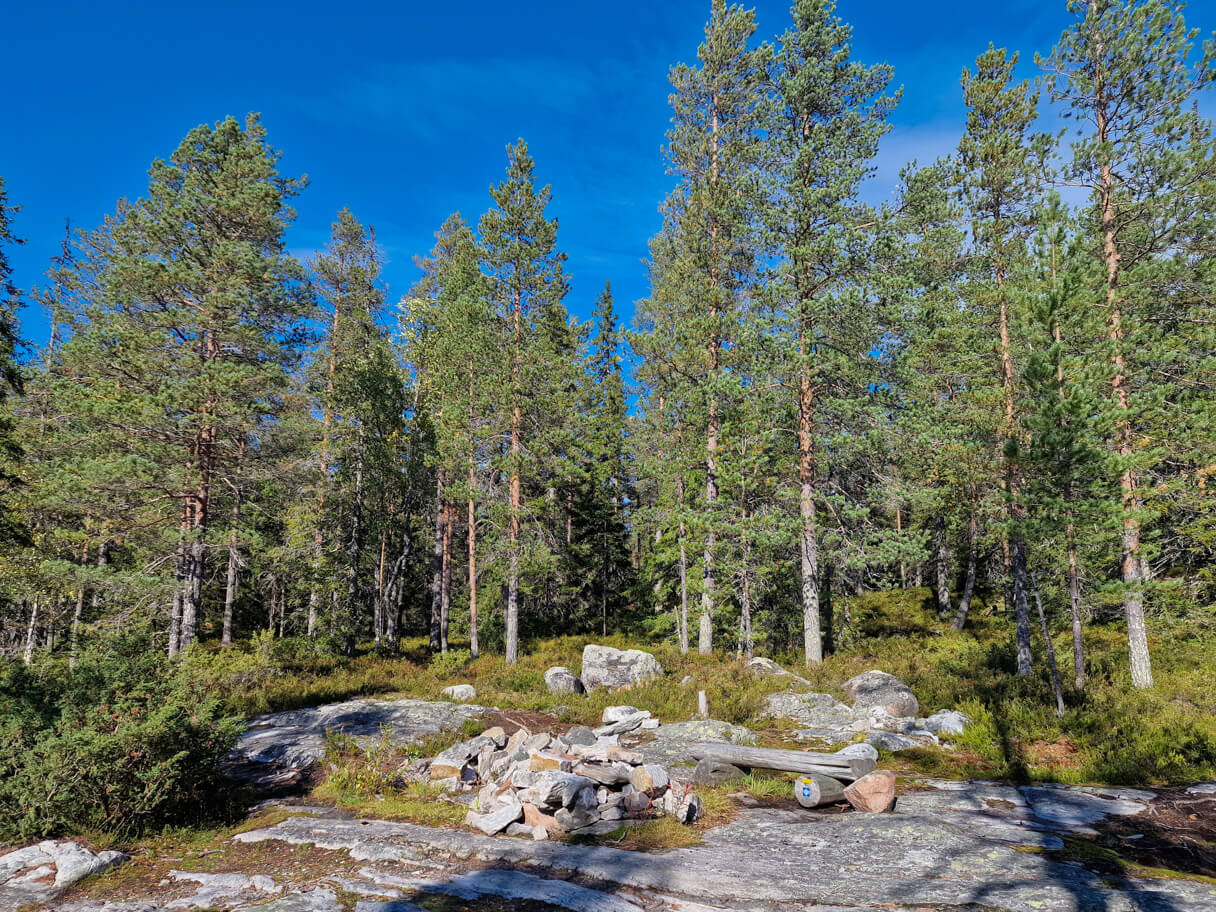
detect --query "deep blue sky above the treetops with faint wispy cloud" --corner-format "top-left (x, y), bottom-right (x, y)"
top-left (0, 0), bottom-right (1216, 342)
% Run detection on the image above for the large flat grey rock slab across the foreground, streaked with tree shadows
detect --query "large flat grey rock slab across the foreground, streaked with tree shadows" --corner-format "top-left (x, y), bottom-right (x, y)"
top-left (240, 799), bottom-right (1216, 912)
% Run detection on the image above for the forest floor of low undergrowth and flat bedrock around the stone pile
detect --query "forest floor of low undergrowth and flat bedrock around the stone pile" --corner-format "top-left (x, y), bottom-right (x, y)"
top-left (9, 591), bottom-right (1216, 912)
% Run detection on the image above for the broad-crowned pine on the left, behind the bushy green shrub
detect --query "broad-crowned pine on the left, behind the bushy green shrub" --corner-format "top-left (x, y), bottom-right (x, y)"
top-left (51, 116), bottom-right (306, 653)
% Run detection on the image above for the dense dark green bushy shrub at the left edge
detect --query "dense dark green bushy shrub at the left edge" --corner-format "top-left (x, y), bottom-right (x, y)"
top-left (0, 632), bottom-right (241, 841)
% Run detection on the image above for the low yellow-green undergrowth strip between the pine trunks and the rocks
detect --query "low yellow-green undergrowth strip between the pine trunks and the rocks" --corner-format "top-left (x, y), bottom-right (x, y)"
top-left (190, 590), bottom-right (1216, 784)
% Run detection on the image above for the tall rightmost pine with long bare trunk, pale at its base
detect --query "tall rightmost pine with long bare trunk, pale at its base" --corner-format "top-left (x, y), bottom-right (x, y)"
top-left (1041, 0), bottom-right (1216, 687)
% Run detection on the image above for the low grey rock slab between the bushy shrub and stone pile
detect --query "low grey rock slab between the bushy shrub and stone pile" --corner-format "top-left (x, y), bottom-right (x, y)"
top-left (229, 699), bottom-right (486, 770)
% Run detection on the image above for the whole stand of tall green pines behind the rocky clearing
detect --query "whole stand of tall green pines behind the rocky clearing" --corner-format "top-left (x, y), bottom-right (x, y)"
top-left (0, 0), bottom-right (1216, 687)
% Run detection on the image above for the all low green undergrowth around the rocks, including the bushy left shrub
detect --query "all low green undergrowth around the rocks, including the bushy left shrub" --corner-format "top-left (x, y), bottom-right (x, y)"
top-left (7, 590), bottom-right (1216, 845)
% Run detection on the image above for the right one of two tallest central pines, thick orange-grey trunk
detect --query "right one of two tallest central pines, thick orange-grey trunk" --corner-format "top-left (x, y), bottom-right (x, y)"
top-left (765, 0), bottom-right (897, 664)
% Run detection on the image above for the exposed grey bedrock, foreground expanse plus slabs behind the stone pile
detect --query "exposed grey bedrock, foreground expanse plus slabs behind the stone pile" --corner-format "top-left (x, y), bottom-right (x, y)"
top-left (0, 669), bottom-right (1216, 912)
